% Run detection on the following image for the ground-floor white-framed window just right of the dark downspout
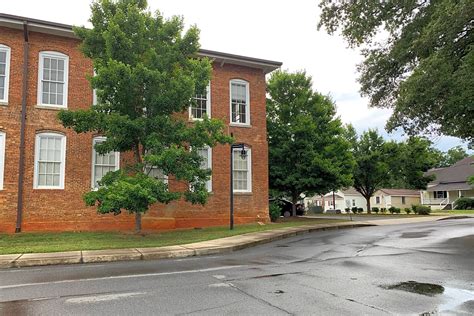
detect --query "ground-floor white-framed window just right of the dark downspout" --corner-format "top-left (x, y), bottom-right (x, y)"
top-left (33, 133), bottom-right (66, 189)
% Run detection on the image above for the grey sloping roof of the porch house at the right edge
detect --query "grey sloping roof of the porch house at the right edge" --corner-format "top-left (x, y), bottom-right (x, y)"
top-left (425, 156), bottom-right (474, 191)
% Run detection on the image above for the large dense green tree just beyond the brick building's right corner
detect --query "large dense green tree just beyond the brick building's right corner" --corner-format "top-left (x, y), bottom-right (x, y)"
top-left (267, 71), bottom-right (354, 215)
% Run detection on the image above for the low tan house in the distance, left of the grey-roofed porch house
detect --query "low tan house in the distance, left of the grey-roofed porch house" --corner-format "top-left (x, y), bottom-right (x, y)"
top-left (370, 189), bottom-right (420, 210)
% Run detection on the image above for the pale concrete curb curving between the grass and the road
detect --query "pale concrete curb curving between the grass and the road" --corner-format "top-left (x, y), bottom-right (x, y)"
top-left (0, 222), bottom-right (376, 269)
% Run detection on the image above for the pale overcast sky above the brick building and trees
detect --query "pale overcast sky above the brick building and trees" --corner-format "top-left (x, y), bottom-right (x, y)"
top-left (0, 0), bottom-right (466, 151)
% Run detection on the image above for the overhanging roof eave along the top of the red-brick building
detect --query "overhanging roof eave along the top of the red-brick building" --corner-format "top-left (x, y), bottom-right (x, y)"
top-left (0, 13), bottom-right (282, 74)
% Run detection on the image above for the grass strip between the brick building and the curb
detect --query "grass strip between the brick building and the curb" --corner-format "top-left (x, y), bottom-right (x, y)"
top-left (0, 218), bottom-right (342, 254)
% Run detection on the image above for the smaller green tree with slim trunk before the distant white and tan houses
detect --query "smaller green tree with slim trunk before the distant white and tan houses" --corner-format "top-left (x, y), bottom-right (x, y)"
top-left (354, 130), bottom-right (390, 214)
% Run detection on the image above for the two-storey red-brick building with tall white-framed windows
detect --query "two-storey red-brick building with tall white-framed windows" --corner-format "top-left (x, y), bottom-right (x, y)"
top-left (0, 14), bottom-right (281, 232)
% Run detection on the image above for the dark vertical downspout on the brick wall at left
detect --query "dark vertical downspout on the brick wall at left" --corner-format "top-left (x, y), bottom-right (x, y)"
top-left (15, 21), bottom-right (30, 233)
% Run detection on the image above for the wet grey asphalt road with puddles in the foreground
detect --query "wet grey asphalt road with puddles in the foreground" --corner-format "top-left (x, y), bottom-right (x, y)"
top-left (0, 219), bottom-right (474, 315)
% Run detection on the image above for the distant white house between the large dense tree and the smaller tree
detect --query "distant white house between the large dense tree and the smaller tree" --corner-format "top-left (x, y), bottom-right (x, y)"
top-left (305, 187), bottom-right (367, 212)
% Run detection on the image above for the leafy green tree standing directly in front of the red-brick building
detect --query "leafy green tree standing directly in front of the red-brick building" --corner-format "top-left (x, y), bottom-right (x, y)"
top-left (59, 0), bottom-right (232, 231)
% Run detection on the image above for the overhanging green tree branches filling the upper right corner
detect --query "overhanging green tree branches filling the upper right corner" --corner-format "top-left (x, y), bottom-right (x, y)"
top-left (318, 0), bottom-right (474, 142)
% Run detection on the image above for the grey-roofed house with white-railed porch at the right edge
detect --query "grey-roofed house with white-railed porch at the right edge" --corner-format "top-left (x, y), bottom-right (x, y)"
top-left (421, 156), bottom-right (474, 209)
